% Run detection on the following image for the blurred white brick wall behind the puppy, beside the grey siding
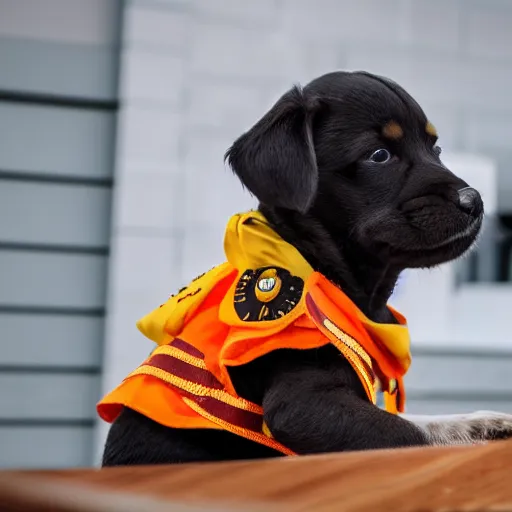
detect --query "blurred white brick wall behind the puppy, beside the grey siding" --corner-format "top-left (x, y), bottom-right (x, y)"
top-left (96, 0), bottom-right (512, 458)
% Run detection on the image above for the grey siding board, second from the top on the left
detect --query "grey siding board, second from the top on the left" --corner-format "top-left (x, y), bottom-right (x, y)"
top-left (0, 102), bottom-right (115, 179)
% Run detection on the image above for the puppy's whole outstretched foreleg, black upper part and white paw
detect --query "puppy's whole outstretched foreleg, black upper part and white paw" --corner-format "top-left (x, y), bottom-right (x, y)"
top-left (260, 346), bottom-right (512, 454)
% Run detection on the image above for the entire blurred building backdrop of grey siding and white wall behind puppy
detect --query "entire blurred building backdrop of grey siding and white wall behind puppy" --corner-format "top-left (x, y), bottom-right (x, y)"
top-left (0, 0), bottom-right (512, 468)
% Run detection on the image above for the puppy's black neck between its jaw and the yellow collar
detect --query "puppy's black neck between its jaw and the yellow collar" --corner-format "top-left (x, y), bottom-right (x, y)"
top-left (259, 205), bottom-right (400, 323)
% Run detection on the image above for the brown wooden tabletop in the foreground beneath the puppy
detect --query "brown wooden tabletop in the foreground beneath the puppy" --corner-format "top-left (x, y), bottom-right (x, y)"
top-left (0, 441), bottom-right (512, 512)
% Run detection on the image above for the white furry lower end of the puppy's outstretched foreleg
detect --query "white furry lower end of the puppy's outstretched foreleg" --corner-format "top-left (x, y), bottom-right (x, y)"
top-left (401, 411), bottom-right (512, 445)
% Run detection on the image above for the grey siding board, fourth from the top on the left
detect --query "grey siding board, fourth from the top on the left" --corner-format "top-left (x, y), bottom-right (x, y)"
top-left (0, 251), bottom-right (107, 312)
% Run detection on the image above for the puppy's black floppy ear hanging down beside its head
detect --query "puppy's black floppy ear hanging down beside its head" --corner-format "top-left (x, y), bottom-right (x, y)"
top-left (225, 86), bottom-right (319, 212)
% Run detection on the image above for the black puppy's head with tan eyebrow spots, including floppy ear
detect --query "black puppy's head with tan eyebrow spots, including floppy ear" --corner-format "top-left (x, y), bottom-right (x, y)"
top-left (226, 72), bottom-right (483, 268)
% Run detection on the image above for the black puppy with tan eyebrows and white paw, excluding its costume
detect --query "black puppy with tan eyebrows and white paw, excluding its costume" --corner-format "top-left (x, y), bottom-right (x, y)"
top-left (103, 72), bottom-right (512, 466)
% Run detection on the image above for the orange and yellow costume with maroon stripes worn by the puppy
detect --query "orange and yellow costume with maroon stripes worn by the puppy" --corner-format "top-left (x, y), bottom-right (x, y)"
top-left (97, 211), bottom-right (410, 455)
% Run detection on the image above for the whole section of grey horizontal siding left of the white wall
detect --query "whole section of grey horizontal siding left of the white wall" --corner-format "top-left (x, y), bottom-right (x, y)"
top-left (0, 0), bottom-right (122, 468)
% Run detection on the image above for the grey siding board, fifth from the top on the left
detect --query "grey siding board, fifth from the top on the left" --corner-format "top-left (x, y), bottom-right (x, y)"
top-left (0, 313), bottom-right (104, 368)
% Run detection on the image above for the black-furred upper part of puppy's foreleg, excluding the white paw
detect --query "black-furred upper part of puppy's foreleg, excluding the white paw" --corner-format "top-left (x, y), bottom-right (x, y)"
top-left (262, 345), bottom-right (431, 455)
